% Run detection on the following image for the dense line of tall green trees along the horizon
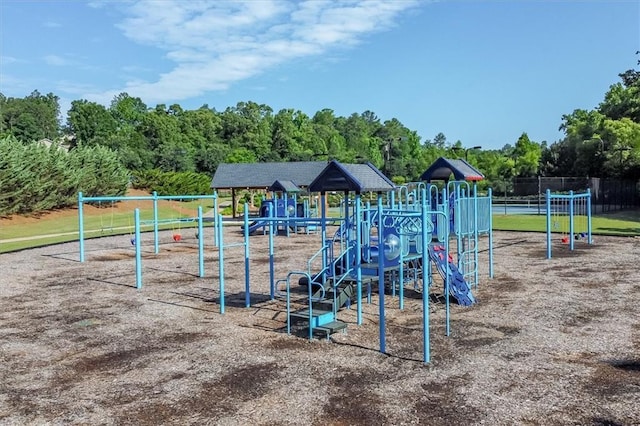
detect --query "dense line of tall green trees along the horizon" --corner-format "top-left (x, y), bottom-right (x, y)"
top-left (0, 55), bottom-right (640, 196)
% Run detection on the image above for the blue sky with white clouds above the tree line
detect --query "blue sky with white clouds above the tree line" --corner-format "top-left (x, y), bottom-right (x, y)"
top-left (0, 0), bottom-right (640, 149)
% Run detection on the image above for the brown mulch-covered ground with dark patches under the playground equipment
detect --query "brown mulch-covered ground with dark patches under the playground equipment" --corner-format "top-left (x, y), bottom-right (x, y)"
top-left (0, 227), bottom-right (640, 425)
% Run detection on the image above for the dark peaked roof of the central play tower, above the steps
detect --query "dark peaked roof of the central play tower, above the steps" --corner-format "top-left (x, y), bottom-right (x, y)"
top-left (308, 160), bottom-right (395, 192)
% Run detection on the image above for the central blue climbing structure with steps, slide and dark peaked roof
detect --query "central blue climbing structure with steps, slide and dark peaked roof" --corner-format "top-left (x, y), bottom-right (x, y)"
top-left (256, 161), bottom-right (492, 362)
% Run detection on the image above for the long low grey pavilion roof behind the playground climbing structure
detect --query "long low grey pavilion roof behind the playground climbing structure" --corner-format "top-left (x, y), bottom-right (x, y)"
top-left (211, 161), bottom-right (327, 189)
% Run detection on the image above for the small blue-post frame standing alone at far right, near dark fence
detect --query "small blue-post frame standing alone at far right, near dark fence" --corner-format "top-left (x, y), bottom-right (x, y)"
top-left (546, 189), bottom-right (593, 259)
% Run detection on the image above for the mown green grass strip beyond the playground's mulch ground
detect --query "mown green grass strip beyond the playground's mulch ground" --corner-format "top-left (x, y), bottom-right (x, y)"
top-left (0, 200), bottom-right (640, 253)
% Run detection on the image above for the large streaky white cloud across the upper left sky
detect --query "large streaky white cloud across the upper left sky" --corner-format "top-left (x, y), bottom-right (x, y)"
top-left (87, 0), bottom-right (420, 103)
